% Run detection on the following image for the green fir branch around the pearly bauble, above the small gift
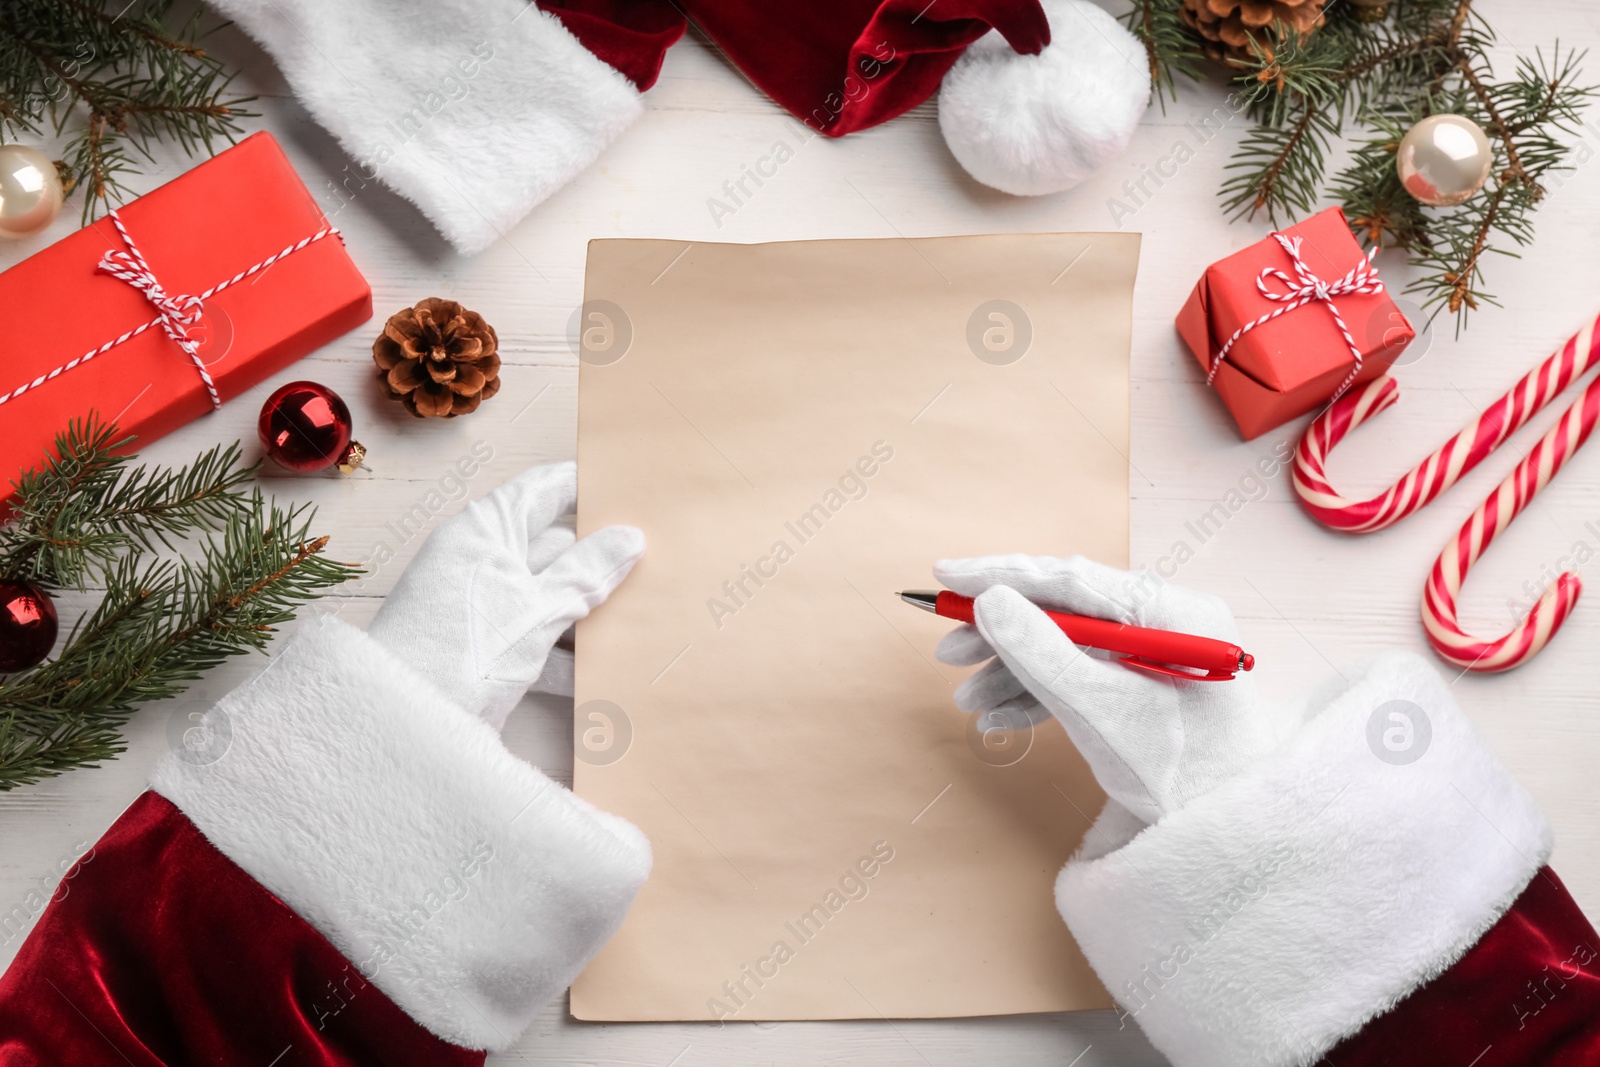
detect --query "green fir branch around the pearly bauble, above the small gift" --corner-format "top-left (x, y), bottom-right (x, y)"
top-left (1150, 0), bottom-right (1595, 328)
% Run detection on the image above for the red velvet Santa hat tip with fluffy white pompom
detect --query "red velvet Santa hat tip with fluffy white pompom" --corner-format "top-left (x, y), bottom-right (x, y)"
top-left (656, 0), bottom-right (1150, 195)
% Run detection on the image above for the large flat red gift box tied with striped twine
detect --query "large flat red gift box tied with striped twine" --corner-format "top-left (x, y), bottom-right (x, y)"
top-left (0, 133), bottom-right (373, 501)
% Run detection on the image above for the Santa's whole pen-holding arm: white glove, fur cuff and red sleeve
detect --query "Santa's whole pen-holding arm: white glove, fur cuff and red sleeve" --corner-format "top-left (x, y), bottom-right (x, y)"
top-left (934, 555), bottom-right (1580, 1067)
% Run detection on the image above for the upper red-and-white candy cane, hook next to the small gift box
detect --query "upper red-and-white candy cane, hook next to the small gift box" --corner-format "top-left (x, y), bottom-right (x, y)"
top-left (1294, 310), bottom-right (1600, 533)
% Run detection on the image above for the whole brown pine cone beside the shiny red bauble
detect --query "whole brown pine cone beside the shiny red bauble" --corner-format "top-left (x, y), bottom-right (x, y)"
top-left (373, 296), bottom-right (499, 419)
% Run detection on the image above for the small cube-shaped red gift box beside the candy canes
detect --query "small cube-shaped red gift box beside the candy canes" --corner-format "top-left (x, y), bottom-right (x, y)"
top-left (1178, 208), bottom-right (1416, 438)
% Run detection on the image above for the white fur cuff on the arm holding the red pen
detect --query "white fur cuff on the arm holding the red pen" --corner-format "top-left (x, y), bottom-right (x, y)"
top-left (1056, 654), bottom-right (1550, 1067)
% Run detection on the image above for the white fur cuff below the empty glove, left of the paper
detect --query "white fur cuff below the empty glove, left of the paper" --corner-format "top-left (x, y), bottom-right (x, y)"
top-left (150, 617), bottom-right (650, 1049)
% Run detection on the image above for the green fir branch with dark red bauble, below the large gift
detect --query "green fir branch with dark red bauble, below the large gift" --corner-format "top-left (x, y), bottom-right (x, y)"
top-left (0, 422), bottom-right (358, 792)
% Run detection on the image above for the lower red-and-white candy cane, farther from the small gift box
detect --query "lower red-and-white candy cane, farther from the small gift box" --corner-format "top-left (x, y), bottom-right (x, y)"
top-left (1413, 375), bottom-right (1600, 670)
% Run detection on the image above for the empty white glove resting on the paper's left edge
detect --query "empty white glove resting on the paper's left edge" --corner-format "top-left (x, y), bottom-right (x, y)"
top-left (366, 462), bottom-right (645, 729)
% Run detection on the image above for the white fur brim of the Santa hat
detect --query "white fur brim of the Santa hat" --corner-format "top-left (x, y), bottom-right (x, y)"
top-left (211, 0), bottom-right (643, 253)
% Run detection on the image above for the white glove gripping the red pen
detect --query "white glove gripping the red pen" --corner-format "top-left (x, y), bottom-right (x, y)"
top-left (933, 555), bottom-right (1294, 822)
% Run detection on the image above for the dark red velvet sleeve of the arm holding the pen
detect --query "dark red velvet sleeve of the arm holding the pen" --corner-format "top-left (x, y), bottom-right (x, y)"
top-left (1325, 867), bottom-right (1600, 1067)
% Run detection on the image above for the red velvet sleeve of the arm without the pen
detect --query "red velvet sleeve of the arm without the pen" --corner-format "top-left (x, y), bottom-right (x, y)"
top-left (0, 793), bottom-right (485, 1067)
